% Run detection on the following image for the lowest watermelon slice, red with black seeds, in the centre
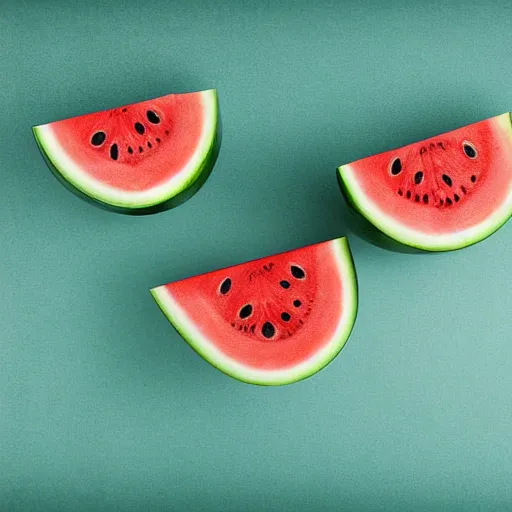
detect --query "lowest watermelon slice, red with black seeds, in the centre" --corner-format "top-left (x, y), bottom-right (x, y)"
top-left (151, 238), bottom-right (357, 385)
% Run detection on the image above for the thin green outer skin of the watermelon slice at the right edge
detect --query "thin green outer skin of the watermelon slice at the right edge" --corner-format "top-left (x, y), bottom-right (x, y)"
top-left (336, 113), bottom-right (512, 252)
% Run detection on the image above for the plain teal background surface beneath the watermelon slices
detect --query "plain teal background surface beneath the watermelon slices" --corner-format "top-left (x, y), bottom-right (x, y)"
top-left (0, 0), bottom-right (512, 512)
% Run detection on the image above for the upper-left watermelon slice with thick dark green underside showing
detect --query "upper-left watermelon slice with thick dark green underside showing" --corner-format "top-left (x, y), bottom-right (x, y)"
top-left (33, 90), bottom-right (221, 214)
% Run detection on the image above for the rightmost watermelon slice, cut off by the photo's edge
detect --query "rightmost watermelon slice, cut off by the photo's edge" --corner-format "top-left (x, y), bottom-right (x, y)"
top-left (337, 113), bottom-right (512, 251)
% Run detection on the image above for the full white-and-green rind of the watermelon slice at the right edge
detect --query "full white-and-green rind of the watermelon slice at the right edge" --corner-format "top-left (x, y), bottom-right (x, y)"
top-left (337, 113), bottom-right (512, 252)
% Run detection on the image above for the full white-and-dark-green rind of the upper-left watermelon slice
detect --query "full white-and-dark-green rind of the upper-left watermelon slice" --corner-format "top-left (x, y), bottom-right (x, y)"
top-left (32, 89), bottom-right (222, 215)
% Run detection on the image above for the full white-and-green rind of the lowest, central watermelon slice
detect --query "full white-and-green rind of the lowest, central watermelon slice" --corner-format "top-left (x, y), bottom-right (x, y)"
top-left (150, 238), bottom-right (358, 386)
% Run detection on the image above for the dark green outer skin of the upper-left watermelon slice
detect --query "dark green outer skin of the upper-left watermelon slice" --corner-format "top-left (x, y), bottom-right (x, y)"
top-left (32, 91), bottom-right (222, 216)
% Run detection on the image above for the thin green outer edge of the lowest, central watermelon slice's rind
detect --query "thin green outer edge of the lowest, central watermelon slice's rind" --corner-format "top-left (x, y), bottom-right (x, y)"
top-left (150, 238), bottom-right (359, 386)
